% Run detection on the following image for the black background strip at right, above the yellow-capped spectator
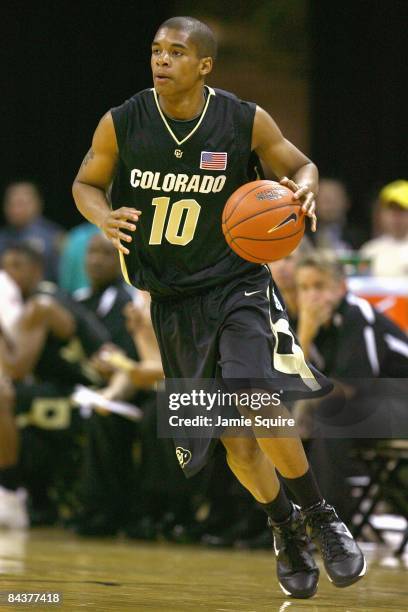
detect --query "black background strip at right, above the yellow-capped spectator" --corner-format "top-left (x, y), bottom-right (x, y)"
top-left (309, 0), bottom-right (408, 225)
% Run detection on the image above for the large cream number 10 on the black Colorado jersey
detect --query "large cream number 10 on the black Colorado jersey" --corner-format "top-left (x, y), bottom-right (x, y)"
top-left (149, 197), bottom-right (201, 246)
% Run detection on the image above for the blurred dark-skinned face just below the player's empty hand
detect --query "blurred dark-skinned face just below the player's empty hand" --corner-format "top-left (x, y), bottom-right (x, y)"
top-left (86, 235), bottom-right (120, 287)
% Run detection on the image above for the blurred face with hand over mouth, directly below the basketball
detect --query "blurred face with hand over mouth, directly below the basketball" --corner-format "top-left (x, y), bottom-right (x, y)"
top-left (296, 266), bottom-right (345, 311)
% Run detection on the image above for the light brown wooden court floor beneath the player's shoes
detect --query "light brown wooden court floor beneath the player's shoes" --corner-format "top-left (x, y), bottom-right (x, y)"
top-left (0, 529), bottom-right (408, 612)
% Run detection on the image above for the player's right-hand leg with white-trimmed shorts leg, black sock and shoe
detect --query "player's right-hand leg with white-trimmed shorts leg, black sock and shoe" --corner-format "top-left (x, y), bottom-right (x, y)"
top-left (220, 280), bottom-right (365, 586)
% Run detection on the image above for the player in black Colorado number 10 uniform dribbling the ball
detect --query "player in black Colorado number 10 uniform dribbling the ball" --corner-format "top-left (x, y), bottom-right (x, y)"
top-left (73, 17), bottom-right (365, 598)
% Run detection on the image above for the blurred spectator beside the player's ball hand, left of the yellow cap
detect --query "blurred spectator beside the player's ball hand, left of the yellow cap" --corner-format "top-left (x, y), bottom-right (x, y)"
top-left (309, 178), bottom-right (364, 253)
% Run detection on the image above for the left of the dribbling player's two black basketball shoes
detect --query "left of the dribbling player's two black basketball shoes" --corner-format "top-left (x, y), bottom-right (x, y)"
top-left (268, 506), bottom-right (319, 599)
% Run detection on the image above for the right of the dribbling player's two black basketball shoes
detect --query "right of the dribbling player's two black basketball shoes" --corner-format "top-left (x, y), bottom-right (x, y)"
top-left (303, 501), bottom-right (367, 587)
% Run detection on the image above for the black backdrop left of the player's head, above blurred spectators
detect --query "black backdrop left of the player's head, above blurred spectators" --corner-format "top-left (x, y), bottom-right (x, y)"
top-left (0, 0), bottom-right (168, 226)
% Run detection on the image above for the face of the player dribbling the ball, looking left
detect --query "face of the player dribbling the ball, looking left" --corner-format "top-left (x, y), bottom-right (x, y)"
top-left (151, 28), bottom-right (211, 96)
